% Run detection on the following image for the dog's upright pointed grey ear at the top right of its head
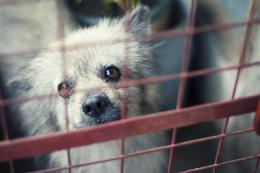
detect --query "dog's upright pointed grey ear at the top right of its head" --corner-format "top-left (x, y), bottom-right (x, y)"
top-left (123, 5), bottom-right (151, 35)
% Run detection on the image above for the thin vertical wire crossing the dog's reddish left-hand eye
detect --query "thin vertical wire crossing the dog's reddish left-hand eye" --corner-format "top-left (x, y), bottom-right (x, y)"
top-left (56, 0), bottom-right (72, 173)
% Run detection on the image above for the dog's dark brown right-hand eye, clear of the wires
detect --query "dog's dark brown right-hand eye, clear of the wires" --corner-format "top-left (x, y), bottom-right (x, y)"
top-left (103, 65), bottom-right (121, 82)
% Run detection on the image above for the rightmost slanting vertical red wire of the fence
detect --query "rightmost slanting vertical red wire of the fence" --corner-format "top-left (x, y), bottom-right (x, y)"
top-left (212, 0), bottom-right (256, 173)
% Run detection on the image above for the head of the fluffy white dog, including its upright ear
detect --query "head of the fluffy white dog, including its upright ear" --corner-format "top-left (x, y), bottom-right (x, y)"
top-left (19, 7), bottom-right (155, 128)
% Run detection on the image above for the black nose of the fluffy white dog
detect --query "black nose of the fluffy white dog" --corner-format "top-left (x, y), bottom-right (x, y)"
top-left (82, 96), bottom-right (110, 117)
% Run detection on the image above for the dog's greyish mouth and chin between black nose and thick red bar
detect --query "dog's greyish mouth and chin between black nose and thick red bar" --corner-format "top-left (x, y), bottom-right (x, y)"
top-left (77, 106), bottom-right (120, 128)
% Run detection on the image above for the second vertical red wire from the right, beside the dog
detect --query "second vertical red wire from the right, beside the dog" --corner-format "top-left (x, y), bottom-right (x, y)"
top-left (167, 0), bottom-right (197, 173)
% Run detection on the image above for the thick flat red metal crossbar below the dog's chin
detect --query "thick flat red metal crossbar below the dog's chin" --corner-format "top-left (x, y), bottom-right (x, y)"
top-left (0, 95), bottom-right (260, 161)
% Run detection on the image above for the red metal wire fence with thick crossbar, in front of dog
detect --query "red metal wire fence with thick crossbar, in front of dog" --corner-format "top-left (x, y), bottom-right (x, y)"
top-left (0, 0), bottom-right (260, 173)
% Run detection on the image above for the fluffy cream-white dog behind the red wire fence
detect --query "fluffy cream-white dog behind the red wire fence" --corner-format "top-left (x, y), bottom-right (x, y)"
top-left (4, 6), bottom-right (170, 173)
